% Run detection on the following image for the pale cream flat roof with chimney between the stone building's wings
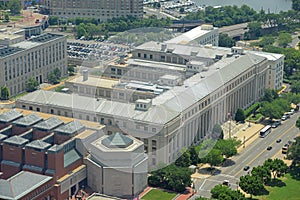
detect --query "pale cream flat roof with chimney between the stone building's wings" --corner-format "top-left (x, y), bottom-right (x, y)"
top-left (67, 75), bottom-right (119, 88)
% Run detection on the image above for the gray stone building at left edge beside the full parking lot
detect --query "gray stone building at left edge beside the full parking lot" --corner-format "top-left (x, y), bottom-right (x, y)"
top-left (0, 33), bottom-right (67, 96)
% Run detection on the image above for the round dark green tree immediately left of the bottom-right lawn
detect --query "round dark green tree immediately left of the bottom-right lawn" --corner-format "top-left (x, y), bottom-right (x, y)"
top-left (239, 175), bottom-right (265, 199)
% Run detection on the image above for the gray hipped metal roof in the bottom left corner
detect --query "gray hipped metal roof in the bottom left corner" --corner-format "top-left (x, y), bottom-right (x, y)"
top-left (0, 171), bottom-right (52, 200)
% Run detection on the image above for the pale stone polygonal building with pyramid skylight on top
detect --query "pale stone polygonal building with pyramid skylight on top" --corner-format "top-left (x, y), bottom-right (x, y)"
top-left (86, 133), bottom-right (148, 198)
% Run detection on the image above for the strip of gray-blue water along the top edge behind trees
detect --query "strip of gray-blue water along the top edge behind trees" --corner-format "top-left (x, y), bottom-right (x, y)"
top-left (194, 0), bottom-right (292, 13)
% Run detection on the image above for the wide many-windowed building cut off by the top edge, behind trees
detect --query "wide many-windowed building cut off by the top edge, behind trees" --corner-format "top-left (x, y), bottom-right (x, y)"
top-left (41, 0), bottom-right (143, 22)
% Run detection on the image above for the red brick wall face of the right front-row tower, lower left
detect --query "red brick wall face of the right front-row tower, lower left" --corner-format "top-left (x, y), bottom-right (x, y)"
top-left (25, 148), bottom-right (45, 168)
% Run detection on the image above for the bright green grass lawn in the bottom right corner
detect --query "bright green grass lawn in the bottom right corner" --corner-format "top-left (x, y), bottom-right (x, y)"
top-left (256, 174), bottom-right (300, 200)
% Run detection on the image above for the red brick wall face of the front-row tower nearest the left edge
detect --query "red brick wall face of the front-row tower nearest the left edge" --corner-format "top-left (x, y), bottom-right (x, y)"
top-left (3, 143), bottom-right (22, 163)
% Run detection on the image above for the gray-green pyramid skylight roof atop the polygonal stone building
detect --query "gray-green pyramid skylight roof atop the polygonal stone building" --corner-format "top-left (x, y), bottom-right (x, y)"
top-left (102, 133), bottom-right (133, 148)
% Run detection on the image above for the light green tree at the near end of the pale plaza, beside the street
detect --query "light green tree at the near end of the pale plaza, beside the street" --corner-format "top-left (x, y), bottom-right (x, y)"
top-left (214, 139), bottom-right (240, 158)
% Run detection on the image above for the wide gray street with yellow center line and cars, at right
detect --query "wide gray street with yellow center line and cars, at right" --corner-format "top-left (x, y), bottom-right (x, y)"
top-left (191, 112), bottom-right (300, 199)
